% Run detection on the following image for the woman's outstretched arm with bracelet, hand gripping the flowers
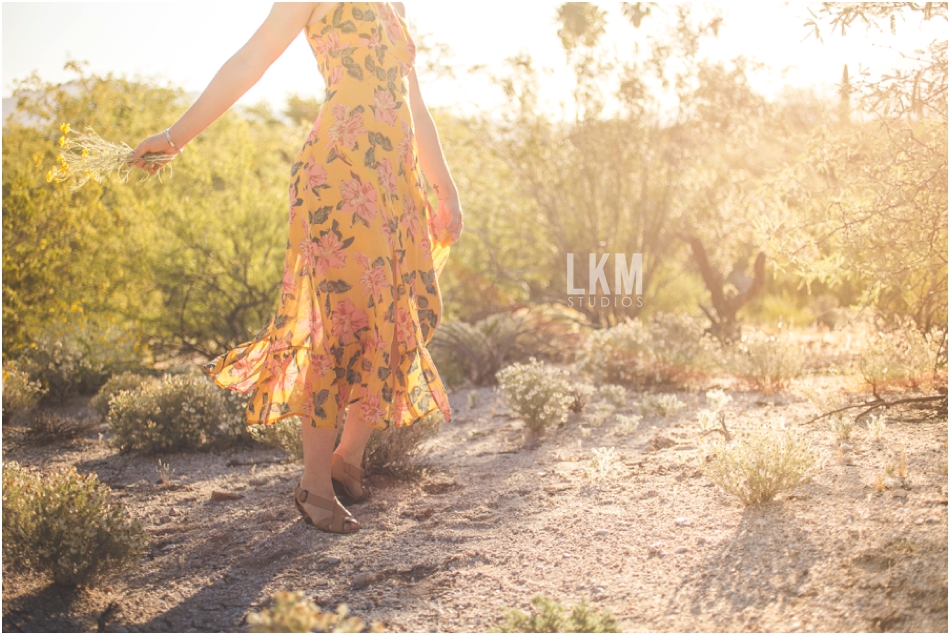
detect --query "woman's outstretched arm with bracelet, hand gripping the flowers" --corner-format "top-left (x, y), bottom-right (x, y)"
top-left (132, 2), bottom-right (326, 173)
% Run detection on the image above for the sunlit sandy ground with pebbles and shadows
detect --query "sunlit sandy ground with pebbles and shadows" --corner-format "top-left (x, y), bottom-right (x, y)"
top-left (3, 370), bottom-right (947, 632)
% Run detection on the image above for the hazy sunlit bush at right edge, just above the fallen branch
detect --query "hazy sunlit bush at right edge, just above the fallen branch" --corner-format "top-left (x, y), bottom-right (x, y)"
top-left (860, 320), bottom-right (946, 392)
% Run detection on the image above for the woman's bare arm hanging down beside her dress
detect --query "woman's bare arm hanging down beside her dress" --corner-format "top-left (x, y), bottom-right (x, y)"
top-left (393, 2), bottom-right (462, 242)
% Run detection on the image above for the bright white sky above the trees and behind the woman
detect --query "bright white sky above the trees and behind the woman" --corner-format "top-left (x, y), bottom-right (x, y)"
top-left (3, 0), bottom-right (947, 119)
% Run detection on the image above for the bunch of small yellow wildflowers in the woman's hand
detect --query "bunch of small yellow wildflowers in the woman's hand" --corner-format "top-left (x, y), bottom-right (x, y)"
top-left (46, 123), bottom-right (177, 191)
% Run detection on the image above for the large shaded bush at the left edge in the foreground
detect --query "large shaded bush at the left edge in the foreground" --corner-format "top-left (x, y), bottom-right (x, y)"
top-left (3, 461), bottom-right (145, 585)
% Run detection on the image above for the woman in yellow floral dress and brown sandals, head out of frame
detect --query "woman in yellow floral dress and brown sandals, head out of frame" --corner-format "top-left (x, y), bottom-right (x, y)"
top-left (132, 2), bottom-right (462, 533)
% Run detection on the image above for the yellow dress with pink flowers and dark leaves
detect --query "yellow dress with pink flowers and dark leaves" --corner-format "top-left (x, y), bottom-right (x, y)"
top-left (203, 2), bottom-right (451, 429)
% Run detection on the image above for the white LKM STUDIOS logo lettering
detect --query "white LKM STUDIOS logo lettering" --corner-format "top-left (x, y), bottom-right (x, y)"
top-left (567, 253), bottom-right (643, 308)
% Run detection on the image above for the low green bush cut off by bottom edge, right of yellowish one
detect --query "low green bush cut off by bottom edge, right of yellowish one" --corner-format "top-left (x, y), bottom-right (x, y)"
top-left (492, 594), bottom-right (620, 633)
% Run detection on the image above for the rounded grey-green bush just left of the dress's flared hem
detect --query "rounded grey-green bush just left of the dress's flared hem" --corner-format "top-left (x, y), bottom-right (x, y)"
top-left (109, 373), bottom-right (235, 454)
